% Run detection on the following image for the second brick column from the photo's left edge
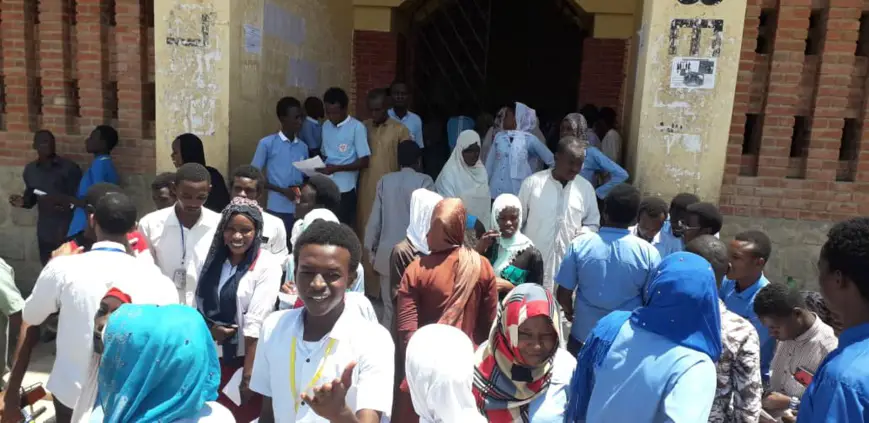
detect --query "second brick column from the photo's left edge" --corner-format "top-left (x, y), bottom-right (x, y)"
top-left (39, 0), bottom-right (73, 134)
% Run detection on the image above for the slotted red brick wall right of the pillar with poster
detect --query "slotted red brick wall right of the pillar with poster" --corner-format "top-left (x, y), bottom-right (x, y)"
top-left (720, 0), bottom-right (869, 221)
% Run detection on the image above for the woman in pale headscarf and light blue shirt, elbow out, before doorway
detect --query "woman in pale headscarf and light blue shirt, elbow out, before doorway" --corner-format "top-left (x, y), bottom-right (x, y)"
top-left (485, 103), bottom-right (555, 199)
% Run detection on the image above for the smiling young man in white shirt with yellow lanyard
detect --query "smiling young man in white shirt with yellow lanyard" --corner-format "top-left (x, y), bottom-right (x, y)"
top-left (250, 220), bottom-right (395, 423)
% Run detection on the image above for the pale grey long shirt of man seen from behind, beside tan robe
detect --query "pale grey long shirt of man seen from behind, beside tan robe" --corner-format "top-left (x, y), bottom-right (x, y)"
top-left (365, 167), bottom-right (434, 275)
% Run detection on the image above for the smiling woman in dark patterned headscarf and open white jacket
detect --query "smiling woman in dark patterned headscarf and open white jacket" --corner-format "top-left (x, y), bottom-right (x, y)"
top-left (196, 197), bottom-right (282, 421)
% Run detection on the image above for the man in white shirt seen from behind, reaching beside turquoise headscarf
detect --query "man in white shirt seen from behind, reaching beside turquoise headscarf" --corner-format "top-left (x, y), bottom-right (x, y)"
top-left (2, 192), bottom-right (171, 423)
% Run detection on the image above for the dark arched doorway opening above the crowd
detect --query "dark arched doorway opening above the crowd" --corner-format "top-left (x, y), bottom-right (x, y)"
top-left (399, 0), bottom-right (587, 125)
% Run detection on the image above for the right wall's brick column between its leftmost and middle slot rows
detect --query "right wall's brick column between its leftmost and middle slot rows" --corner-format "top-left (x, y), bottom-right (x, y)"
top-left (757, 0), bottom-right (812, 179)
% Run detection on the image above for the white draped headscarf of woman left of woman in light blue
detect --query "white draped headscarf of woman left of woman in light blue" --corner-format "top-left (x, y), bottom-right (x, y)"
top-left (435, 131), bottom-right (491, 229)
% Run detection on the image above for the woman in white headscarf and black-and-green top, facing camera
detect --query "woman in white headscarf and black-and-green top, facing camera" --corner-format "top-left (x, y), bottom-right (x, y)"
top-left (476, 194), bottom-right (543, 297)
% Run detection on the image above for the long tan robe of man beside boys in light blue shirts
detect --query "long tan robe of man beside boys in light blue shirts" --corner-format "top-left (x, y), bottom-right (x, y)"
top-left (356, 118), bottom-right (410, 298)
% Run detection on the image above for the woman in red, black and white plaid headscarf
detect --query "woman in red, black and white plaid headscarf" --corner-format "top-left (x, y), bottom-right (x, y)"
top-left (473, 284), bottom-right (576, 423)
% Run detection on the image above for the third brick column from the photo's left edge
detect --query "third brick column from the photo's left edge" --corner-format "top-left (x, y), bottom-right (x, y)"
top-left (75, 0), bottom-right (109, 133)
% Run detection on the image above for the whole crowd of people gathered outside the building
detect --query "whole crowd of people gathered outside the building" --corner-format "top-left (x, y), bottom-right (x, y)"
top-left (0, 82), bottom-right (869, 423)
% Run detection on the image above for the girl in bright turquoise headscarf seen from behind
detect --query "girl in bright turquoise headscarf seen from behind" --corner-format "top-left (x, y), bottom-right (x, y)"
top-left (91, 304), bottom-right (234, 423)
